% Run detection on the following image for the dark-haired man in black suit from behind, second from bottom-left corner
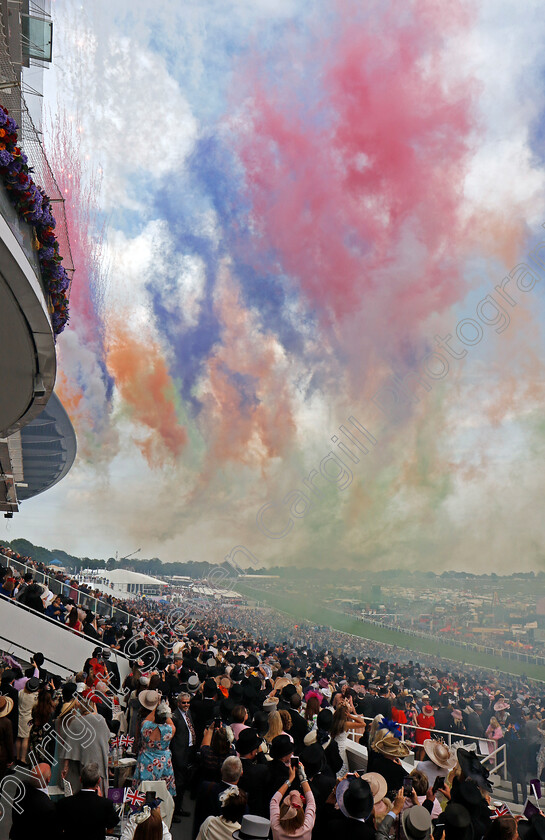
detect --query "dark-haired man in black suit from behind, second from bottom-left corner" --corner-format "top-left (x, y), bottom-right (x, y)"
top-left (56, 762), bottom-right (119, 840)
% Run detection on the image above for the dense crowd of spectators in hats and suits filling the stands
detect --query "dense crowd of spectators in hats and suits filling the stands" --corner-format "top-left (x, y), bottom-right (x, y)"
top-left (0, 548), bottom-right (545, 840)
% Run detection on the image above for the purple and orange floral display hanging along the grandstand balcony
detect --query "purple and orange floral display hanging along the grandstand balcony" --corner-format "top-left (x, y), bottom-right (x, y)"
top-left (0, 105), bottom-right (70, 335)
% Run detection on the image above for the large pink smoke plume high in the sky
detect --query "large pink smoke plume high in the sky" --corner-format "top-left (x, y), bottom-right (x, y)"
top-left (237, 2), bottom-right (473, 346)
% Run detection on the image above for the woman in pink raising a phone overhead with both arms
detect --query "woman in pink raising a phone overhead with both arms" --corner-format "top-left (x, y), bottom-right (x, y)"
top-left (270, 756), bottom-right (316, 840)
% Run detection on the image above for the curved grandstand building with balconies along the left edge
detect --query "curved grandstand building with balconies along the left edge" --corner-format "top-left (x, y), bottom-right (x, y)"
top-left (0, 0), bottom-right (76, 517)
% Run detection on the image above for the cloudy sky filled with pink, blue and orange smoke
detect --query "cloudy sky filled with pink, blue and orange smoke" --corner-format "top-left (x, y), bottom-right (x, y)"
top-left (0, 0), bottom-right (545, 573)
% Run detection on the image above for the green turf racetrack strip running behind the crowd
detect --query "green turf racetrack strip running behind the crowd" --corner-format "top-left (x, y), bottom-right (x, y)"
top-left (233, 582), bottom-right (545, 680)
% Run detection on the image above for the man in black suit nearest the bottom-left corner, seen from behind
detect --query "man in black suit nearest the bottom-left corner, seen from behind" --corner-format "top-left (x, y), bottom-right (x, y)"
top-left (6, 764), bottom-right (59, 840)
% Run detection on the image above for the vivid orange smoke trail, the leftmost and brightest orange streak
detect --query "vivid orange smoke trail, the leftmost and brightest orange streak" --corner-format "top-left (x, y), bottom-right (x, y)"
top-left (106, 325), bottom-right (187, 466)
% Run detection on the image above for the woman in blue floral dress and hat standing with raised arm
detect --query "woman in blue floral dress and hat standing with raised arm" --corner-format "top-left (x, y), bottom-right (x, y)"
top-left (134, 690), bottom-right (176, 796)
